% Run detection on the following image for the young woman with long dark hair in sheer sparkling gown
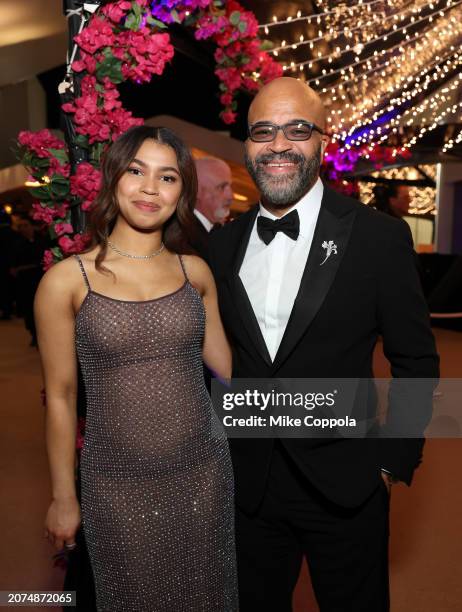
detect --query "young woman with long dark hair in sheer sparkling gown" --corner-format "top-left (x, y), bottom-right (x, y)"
top-left (35, 126), bottom-right (238, 612)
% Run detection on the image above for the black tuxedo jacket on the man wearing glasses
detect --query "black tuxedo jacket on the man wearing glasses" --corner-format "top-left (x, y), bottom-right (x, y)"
top-left (209, 186), bottom-right (439, 512)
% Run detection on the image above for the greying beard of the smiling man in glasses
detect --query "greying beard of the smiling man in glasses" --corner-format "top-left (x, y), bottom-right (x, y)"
top-left (245, 144), bottom-right (321, 208)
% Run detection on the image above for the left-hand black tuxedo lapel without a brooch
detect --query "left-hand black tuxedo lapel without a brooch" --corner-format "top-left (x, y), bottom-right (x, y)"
top-left (228, 206), bottom-right (271, 365)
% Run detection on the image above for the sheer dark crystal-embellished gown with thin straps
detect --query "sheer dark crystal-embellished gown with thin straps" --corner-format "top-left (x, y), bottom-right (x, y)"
top-left (76, 257), bottom-right (238, 612)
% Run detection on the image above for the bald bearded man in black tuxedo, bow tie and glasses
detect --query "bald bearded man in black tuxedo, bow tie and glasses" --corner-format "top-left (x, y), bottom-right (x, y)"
top-left (209, 77), bottom-right (438, 612)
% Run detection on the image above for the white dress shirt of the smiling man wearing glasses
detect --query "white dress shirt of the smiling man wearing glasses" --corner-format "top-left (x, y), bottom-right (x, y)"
top-left (239, 179), bottom-right (324, 361)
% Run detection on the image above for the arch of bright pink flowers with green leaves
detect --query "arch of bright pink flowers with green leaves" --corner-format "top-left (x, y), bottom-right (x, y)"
top-left (18, 0), bottom-right (283, 268)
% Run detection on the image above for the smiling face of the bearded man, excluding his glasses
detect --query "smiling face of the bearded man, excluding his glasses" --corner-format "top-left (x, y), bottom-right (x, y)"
top-left (245, 96), bottom-right (328, 208)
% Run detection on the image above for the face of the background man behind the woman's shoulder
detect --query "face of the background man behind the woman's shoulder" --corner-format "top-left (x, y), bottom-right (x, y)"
top-left (198, 164), bottom-right (233, 223)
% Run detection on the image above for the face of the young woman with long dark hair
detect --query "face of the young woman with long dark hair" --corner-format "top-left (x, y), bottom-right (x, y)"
top-left (116, 138), bottom-right (183, 231)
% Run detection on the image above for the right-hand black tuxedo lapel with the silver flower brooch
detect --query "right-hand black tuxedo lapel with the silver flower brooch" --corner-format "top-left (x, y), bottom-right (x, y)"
top-left (273, 187), bottom-right (356, 372)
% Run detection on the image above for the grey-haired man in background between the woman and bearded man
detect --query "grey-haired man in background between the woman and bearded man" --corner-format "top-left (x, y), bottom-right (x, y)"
top-left (191, 157), bottom-right (233, 259)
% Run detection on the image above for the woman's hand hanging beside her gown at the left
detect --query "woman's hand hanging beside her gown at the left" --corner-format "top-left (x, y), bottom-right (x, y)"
top-left (44, 497), bottom-right (81, 550)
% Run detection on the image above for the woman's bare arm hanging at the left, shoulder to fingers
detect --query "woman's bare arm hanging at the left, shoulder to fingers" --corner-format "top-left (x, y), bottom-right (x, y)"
top-left (35, 260), bottom-right (80, 549)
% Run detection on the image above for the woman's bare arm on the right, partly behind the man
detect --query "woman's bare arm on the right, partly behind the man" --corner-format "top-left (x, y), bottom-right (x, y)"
top-left (186, 256), bottom-right (232, 379)
